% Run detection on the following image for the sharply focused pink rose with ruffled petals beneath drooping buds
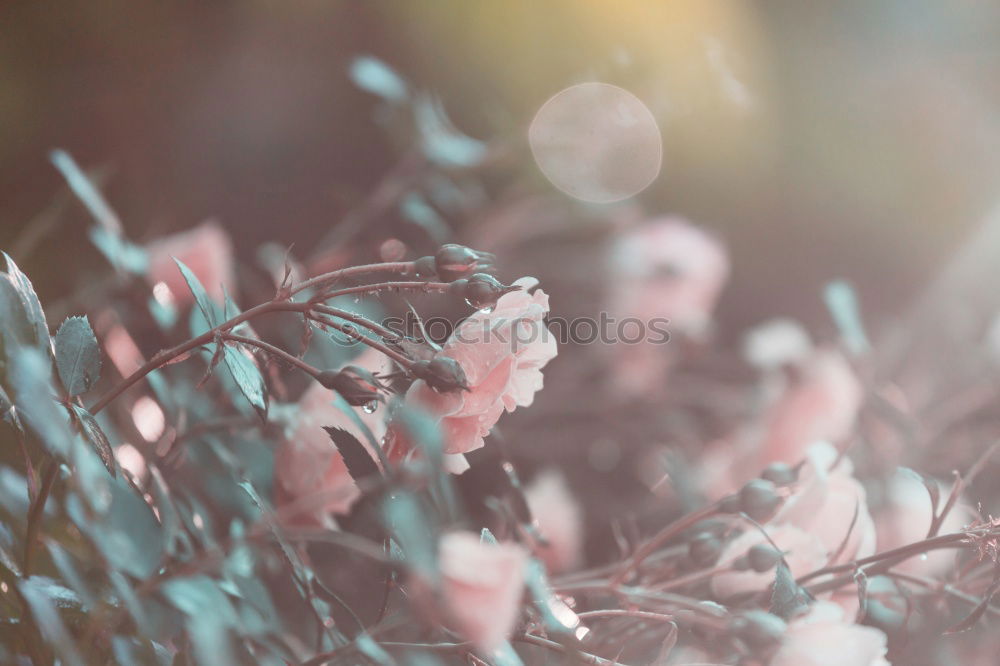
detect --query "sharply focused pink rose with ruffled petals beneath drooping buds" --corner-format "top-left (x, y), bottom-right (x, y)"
top-left (406, 278), bottom-right (556, 454)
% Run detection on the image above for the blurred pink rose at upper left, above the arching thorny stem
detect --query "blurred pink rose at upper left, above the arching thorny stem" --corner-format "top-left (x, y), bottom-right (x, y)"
top-left (146, 222), bottom-right (234, 307)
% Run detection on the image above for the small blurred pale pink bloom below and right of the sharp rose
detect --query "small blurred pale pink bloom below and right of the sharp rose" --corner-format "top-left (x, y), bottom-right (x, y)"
top-left (524, 471), bottom-right (583, 574)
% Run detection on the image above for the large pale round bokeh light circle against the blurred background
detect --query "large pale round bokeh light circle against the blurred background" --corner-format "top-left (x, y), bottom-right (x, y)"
top-left (528, 82), bottom-right (663, 203)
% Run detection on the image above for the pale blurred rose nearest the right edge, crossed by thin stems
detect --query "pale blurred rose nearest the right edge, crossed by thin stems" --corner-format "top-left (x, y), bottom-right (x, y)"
top-left (875, 467), bottom-right (975, 576)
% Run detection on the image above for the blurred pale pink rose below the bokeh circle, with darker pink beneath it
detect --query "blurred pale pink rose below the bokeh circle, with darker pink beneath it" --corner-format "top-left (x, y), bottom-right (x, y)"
top-left (607, 217), bottom-right (729, 398)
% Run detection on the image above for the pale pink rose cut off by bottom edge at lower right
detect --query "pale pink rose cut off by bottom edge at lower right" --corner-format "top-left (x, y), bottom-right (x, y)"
top-left (770, 601), bottom-right (889, 666)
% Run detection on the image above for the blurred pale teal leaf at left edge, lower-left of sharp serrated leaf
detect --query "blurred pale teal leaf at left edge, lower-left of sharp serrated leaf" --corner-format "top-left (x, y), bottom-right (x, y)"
top-left (10, 344), bottom-right (73, 456)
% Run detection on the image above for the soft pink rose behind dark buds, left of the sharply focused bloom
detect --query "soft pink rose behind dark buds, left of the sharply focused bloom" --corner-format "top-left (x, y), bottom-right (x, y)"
top-left (274, 351), bottom-right (387, 527)
